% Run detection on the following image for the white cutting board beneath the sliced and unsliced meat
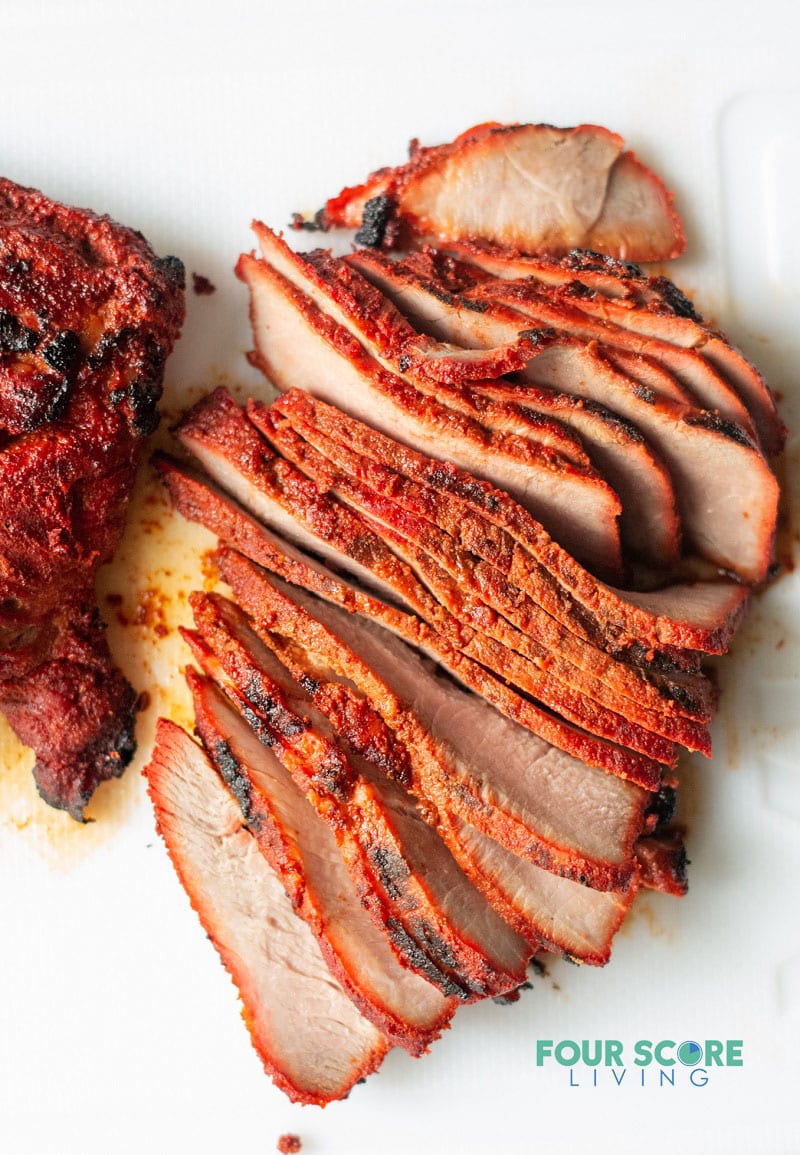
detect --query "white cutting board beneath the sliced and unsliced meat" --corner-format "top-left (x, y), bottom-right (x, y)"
top-left (0, 0), bottom-right (800, 1155)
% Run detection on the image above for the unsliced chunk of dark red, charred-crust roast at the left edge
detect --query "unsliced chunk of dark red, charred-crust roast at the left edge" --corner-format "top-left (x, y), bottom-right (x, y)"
top-left (0, 180), bottom-right (184, 819)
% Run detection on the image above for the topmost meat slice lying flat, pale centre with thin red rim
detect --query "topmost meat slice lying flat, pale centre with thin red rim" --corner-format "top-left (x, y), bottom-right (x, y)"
top-left (321, 125), bottom-right (685, 260)
